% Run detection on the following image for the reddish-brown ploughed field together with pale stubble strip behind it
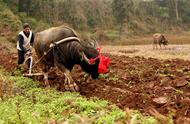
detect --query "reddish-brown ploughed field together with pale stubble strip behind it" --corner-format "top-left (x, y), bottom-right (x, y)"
top-left (0, 45), bottom-right (190, 124)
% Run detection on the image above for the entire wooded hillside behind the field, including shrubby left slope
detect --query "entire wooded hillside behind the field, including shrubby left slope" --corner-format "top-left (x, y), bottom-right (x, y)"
top-left (0, 0), bottom-right (190, 44)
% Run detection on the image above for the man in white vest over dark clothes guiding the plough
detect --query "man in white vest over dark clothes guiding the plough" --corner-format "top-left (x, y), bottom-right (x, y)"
top-left (17, 23), bottom-right (34, 68)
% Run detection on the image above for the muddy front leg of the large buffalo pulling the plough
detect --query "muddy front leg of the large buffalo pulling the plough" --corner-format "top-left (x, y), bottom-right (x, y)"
top-left (54, 61), bottom-right (79, 91)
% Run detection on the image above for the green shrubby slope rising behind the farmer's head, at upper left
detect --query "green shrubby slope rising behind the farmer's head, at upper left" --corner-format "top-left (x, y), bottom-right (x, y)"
top-left (0, 0), bottom-right (49, 42)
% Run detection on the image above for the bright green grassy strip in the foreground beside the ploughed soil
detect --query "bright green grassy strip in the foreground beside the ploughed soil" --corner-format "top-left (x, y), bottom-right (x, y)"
top-left (0, 70), bottom-right (169, 124)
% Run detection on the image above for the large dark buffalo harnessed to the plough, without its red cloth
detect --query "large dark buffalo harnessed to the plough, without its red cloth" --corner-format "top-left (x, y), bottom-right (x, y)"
top-left (34, 26), bottom-right (99, 91)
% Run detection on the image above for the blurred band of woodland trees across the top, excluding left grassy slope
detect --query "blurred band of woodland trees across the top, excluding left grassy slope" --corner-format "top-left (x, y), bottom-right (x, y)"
top-left (0, 0), bottom-right (190, 36)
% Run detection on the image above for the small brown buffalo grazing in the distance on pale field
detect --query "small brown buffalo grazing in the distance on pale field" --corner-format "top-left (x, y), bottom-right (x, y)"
top-left (153, 33), bottom-right (168, 49)
